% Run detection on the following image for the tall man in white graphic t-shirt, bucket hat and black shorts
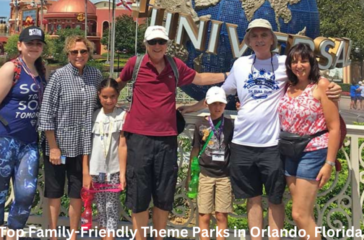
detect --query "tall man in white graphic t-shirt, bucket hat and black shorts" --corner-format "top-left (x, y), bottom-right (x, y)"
top-left (180, 19), bottom-right (341, 240)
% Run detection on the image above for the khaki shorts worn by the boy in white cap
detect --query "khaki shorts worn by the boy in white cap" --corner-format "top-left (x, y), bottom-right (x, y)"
top-left (197, 173), bottom-right (233, 214)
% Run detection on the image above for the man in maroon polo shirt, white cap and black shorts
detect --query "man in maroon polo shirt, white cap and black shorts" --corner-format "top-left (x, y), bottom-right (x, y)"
top-left (118, 26), bottom-right (226, 240)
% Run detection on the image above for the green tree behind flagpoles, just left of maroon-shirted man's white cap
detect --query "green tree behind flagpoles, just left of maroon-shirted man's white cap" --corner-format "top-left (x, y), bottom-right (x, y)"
top-left (101, 15), bottom-right (146, 53)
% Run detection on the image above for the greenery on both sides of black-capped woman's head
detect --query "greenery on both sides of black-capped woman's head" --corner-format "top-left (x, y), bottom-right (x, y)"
top-left (4, 34), bottom-right (55, 60)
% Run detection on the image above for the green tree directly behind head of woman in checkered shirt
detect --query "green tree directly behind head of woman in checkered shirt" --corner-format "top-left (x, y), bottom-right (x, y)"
top-left (53, 28), bottom-right (85, 65)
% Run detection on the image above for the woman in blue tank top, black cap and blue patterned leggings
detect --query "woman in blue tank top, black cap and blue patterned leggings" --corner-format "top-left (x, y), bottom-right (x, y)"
top-left (0, 27), bottom-right (45, 234)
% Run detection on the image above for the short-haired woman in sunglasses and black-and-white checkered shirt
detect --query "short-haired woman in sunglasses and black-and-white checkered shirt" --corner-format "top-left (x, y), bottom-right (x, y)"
top-left (39, 36), bottom-right (102, 239)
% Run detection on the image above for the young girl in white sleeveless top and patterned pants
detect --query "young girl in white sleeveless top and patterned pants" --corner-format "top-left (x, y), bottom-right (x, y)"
top-left (83, 78), bottom-right (127, 234)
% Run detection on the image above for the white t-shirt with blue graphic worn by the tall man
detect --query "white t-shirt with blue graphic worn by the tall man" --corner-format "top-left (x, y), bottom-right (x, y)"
top-left (222, 54), bottom-right (288, 147)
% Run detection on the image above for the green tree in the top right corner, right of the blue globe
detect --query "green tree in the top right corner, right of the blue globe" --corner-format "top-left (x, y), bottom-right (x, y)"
top-left (317, 0), bottom-right (364, 59)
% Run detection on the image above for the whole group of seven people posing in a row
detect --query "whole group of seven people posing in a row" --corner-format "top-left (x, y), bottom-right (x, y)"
top-left (0, 19), bottom-right (341, 240)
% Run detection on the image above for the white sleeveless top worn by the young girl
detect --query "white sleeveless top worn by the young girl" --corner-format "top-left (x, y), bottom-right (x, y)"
top-left (90, 108), bottom-right (125, 176)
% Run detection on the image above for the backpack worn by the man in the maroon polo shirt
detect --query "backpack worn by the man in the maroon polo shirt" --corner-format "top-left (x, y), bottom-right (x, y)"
top-left (127, 54), bottom-right (186, 134)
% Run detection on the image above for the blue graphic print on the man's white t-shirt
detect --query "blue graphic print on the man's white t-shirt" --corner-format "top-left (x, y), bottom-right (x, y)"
top-left (244, 69), bottom-right (279, 99)
